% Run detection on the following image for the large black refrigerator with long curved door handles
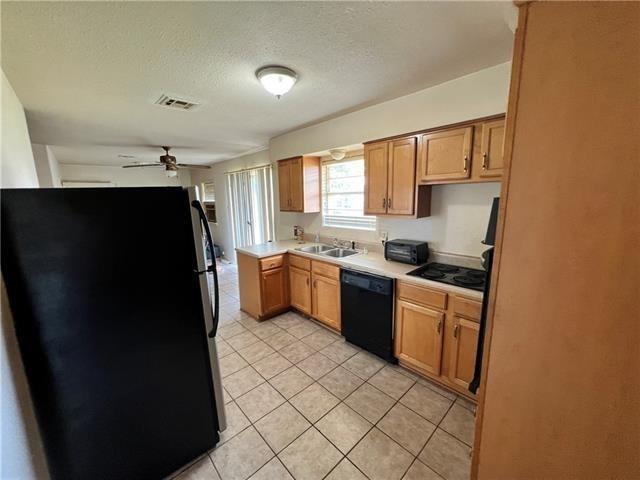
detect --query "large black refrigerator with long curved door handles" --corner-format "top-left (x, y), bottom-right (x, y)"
top-left (0, 187), bottom-right (226, 480)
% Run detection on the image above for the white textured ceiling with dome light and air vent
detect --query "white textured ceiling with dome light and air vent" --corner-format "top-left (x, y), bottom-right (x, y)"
top-left (1, 1), bottom-right (512, 165)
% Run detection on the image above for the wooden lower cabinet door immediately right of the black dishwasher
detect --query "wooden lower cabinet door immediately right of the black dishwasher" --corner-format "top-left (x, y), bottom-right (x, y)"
top-left (395, 300), bottom-right (444, 375)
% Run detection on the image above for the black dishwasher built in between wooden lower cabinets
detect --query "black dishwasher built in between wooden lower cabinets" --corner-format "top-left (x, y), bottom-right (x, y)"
top-left (340, 269), bottom-right (397, 363)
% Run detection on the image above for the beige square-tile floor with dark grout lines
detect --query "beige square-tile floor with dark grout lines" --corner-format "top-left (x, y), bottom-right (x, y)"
top-left (175, 265), bottom-right (474, 480)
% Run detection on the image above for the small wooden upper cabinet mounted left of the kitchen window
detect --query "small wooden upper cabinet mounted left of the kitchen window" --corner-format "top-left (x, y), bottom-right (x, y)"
top-left (278, 156), bottom-right (320, 213)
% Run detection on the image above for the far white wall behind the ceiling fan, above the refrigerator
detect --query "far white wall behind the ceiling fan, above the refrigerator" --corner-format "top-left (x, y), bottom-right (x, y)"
top-left (60, 163), bottom-right (191, 187)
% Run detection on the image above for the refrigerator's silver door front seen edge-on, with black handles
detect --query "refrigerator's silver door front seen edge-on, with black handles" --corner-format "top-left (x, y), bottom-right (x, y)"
top-left (188, 187), bottom-right (227, 432)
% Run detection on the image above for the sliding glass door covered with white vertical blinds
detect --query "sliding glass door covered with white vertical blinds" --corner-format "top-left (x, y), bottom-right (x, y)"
top-left (227, 165), bottom-right (275, 247)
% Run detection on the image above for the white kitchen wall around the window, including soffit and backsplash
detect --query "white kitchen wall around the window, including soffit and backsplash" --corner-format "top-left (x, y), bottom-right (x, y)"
top-left (270, 63), bottom-right (511, 257)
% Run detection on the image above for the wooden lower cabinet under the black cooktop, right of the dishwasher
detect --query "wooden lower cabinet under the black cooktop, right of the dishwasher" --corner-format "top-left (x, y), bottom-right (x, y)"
top-left (394, 282), bottom-right (481, 398)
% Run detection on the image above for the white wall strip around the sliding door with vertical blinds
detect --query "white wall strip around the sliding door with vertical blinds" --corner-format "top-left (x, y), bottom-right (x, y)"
top-left (191, 150), bottom-right (270, 262)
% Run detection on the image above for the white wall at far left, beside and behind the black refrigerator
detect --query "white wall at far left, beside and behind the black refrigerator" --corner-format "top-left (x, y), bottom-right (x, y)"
top-left (0, 72), bottom-right (48, 480)
